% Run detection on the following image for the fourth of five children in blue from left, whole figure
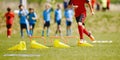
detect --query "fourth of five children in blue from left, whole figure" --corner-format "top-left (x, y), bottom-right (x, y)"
top-left (55, 4), bottom-right (62, 36)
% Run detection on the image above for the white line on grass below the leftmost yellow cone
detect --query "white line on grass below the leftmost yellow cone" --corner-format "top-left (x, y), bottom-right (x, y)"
top-left (3, 54), bottom-right (40, 57)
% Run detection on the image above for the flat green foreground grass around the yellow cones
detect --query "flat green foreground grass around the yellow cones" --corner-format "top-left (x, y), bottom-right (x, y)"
top-left (0, 33), bottom-right (120, 60)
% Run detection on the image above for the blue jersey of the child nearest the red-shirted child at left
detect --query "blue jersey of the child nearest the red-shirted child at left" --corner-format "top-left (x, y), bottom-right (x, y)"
top-left (18, 10), bottom-right (28, 24)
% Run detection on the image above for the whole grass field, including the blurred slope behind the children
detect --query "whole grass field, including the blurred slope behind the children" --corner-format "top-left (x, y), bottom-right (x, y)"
top-left (0, 0), bottom-right (120, 60)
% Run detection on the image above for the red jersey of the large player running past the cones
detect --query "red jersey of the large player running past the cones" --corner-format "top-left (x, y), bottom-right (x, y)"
top-left (69, 0), bottom-right (89, 17)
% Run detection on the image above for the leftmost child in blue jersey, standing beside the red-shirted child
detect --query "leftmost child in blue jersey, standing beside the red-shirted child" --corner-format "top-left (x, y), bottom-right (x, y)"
top-left (18, 5), bottom-right (31, 38)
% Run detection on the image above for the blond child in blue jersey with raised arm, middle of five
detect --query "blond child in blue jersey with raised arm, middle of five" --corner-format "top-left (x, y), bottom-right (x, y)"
top-left (42, 4), bottom-right (53, 36)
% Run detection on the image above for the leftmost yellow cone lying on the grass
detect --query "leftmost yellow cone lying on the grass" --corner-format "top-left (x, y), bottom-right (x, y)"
top-left (8, 41), bottom-right (27, 50)
